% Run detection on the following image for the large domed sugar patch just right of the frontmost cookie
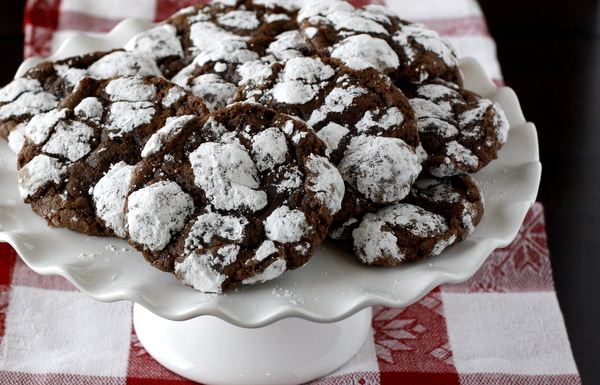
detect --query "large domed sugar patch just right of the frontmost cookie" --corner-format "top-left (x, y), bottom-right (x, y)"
top-left (338, 136), bottom-right (421, 203)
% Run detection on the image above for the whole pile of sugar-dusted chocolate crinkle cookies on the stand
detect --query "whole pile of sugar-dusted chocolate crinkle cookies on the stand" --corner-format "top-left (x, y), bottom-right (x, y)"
top-left (0, 0), bottom-right (508, 293)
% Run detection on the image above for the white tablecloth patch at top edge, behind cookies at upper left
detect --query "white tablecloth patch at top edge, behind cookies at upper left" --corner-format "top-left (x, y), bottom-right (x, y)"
top-left (60, 0), bottom-right (156, 20)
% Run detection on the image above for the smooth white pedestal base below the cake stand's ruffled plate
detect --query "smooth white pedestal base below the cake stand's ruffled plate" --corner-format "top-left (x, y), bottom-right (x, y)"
top-left (133, 304), bottom-right (372, 385)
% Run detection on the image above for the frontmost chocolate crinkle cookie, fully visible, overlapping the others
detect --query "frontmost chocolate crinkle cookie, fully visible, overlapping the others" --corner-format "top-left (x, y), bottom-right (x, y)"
top-left (125, 103), bottom-right (344, 293)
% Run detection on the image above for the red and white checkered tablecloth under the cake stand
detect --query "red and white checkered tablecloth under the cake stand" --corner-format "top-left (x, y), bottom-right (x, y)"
top-left (0, 0), bottom-right (581, 385)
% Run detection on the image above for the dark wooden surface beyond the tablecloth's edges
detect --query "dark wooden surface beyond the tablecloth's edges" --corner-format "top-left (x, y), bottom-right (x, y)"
top-left (0, 0), bottom-right (600, 384)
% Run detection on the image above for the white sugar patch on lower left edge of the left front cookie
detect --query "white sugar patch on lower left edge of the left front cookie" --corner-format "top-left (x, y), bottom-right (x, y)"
top-left (17, 154), bottom-right (67, 199)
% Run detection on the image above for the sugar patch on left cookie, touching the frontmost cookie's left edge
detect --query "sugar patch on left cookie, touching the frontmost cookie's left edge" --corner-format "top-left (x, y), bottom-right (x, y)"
top-left (90, 161), bottom-right (135, 238)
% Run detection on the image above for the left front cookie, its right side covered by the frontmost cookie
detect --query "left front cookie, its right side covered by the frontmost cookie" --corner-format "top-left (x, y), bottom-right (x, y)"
top-left (17, 75), bottom-right (208, 237)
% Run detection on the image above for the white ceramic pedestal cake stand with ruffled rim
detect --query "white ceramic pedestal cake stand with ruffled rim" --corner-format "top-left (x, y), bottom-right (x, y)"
top-left (0, 19), bottom-right (541, 384)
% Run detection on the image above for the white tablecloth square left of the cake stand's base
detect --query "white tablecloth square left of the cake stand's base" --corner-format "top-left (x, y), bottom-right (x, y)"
top-left (0, 286), bottom-right (131, 377)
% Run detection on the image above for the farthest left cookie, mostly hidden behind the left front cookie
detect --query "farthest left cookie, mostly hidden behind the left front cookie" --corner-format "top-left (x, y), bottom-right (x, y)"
top-left (0, 50), bottom-right (162, 143)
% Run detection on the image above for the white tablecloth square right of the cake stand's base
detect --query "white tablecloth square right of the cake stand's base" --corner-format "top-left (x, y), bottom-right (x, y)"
top-left (442, 291), bottom-right (577, 375)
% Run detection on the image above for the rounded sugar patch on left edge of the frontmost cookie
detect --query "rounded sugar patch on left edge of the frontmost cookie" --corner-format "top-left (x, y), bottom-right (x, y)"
top-left (126, 181), bottom-right (194, 250)
